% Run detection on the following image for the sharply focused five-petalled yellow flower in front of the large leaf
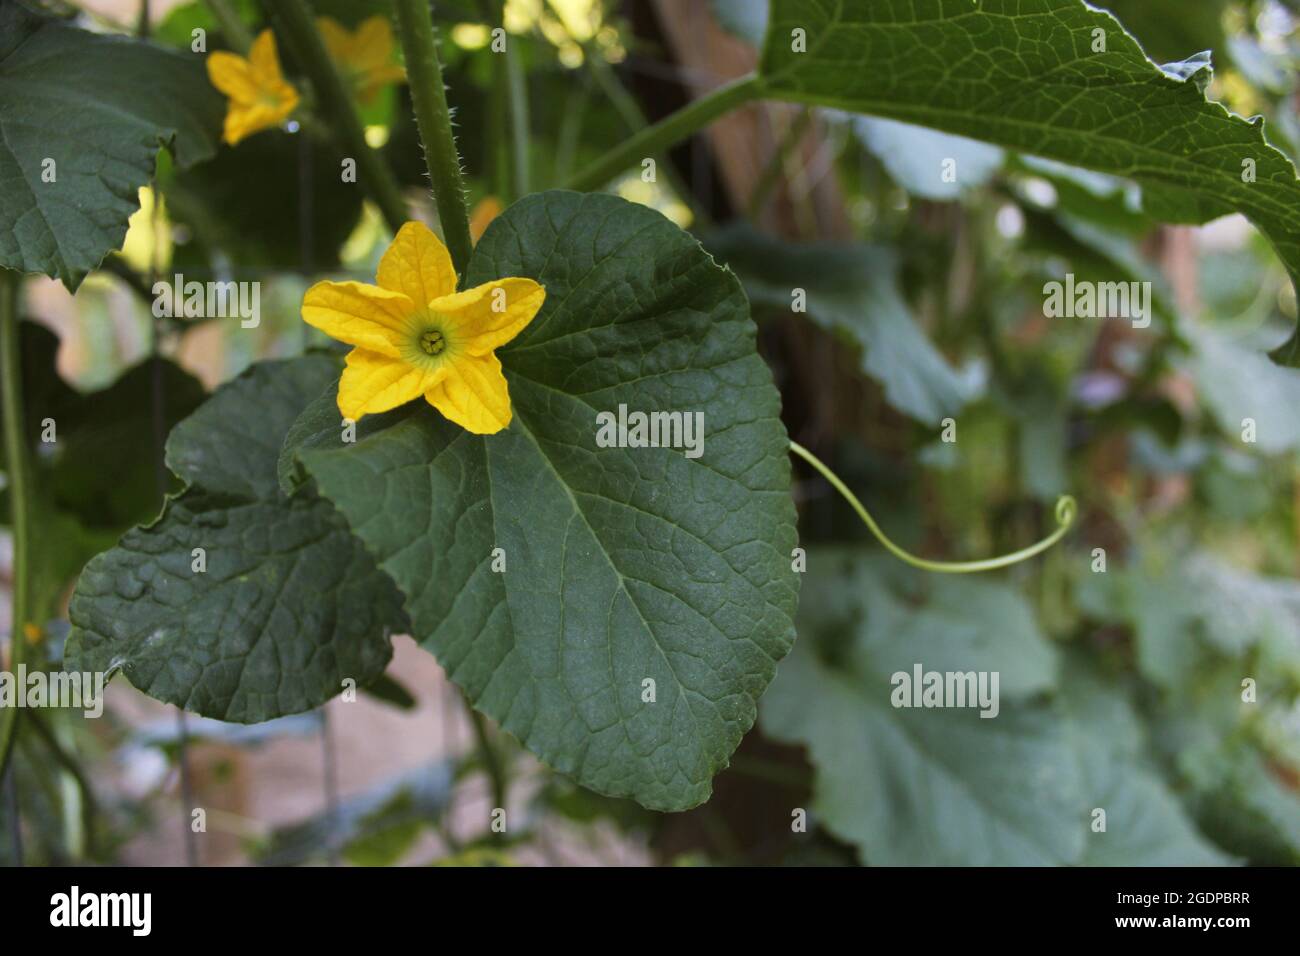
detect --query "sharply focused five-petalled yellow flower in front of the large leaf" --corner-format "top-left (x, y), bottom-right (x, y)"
top-left (303, 222), bottom-right (546, 434)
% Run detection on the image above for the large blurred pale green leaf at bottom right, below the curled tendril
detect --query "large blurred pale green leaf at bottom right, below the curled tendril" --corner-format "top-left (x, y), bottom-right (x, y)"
top-left (780, 561), bottom-right (1229, 866)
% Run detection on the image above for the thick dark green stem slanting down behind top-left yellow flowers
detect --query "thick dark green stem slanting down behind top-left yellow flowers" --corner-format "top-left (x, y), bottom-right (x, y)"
top-left (265, 0), bottom-right (407, 232)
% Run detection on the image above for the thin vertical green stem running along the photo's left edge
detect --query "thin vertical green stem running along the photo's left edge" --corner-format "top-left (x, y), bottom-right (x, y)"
top-left (0, 269), bottom-right (31, 779)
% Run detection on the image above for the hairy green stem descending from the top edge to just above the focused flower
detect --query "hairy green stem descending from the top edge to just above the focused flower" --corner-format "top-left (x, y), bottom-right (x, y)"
top-left (393, 0), bottom-right (483, 281)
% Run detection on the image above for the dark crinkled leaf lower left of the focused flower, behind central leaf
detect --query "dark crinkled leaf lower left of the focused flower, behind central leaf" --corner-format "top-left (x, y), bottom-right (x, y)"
top-left (66, 355), bottom-right (404, 723)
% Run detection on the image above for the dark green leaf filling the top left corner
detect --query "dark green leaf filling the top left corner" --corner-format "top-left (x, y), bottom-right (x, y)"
top-left (0, 3), bottom-right (222, 291)
